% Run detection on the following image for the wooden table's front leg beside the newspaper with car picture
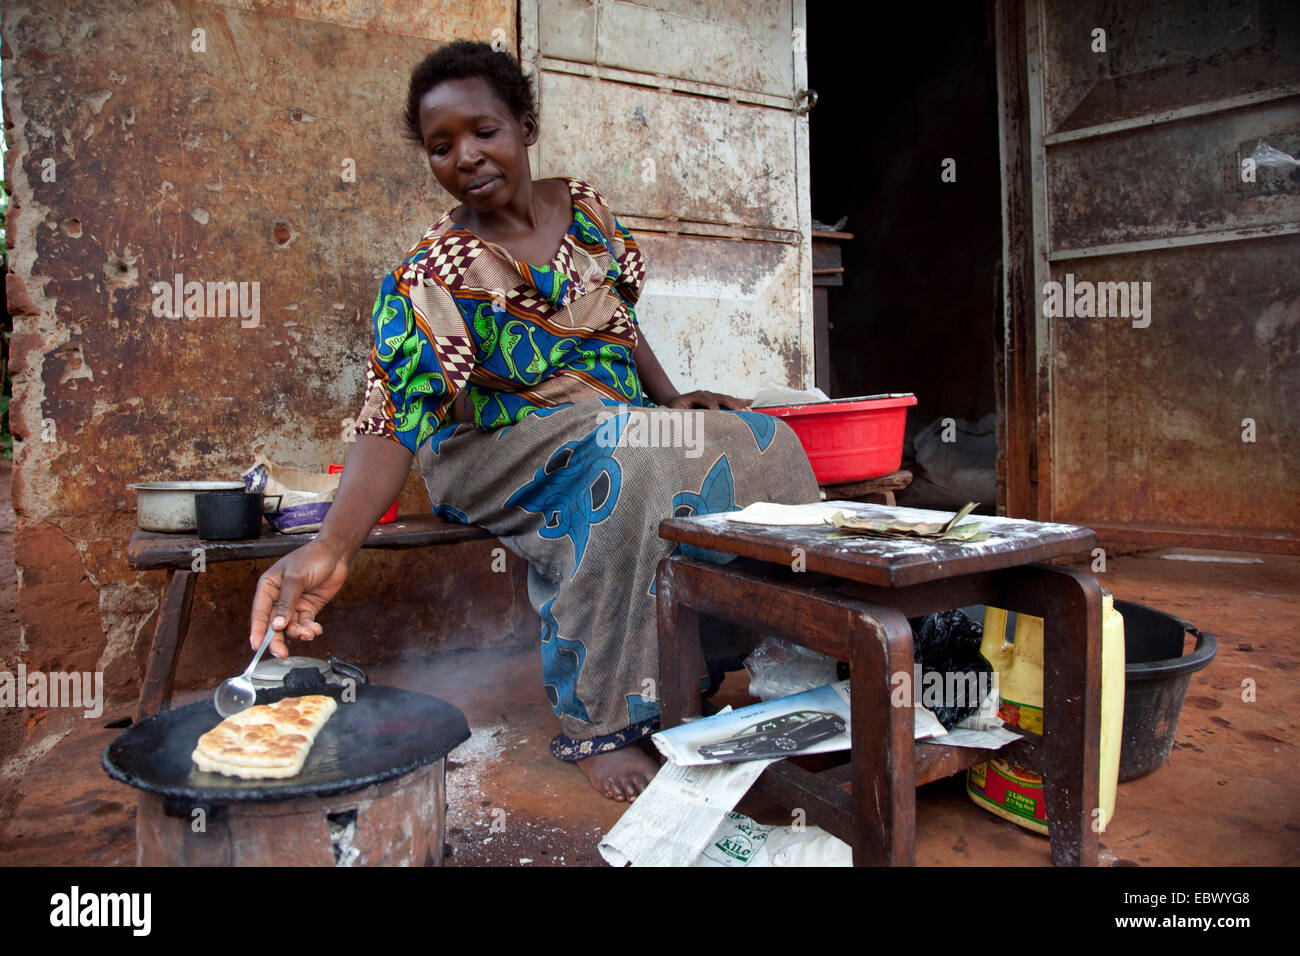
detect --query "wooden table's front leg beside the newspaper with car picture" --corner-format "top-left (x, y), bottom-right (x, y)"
top-left (849, 606), bottom-right (917, 866)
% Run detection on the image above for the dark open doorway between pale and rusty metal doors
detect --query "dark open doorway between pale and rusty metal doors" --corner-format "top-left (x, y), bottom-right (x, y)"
top-left (807, 0), bottom-right (1002, 512)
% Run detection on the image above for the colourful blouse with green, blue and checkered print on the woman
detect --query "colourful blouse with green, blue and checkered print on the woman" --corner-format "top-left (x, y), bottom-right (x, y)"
top-left (356, 179), bottom-right (654, 453)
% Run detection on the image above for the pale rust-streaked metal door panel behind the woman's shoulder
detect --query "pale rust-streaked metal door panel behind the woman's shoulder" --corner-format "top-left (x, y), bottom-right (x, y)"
top-left (520, 0), bottom-right (814, 395)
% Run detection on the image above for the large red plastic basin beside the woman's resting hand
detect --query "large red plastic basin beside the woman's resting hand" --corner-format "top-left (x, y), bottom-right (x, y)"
top-left (750, 394), bottom-right (917, 485)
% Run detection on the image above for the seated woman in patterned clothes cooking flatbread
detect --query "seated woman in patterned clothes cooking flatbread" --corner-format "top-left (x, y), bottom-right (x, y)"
top-left (250, 42), bottom-right (818, 800)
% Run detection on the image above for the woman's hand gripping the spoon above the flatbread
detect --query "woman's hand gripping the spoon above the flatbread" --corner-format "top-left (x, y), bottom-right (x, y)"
top-left (248, 538), bottom-right (347, 657)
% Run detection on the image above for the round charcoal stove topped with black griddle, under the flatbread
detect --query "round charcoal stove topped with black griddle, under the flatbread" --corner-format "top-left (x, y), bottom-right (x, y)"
top-left (103, 670), bottom-right (469, 866)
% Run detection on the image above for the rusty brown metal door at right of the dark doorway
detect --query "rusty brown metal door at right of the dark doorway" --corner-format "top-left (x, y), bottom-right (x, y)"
top-left (998, 0), bottom-right (1300, 551)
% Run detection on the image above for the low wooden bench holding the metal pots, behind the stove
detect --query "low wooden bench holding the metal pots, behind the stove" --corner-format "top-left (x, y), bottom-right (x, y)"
top-left (126, 515), bottom-right (493, 721)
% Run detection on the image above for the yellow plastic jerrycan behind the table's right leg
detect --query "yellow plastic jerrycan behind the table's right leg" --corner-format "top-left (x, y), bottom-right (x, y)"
top-left (966, 592), bottom-right (1125, 836)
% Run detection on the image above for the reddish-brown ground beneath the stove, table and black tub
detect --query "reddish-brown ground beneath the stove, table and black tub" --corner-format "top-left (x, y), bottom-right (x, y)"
top-left (0, 450), bottom-right (1300, 866)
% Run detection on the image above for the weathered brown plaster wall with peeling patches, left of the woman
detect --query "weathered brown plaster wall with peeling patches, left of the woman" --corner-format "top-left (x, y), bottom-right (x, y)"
top-left (0, 0), bottom-right (527, 761)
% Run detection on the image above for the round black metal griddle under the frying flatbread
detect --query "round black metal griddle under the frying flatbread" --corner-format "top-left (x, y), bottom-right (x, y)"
top-left (103, 675), bottom-right (469, 804)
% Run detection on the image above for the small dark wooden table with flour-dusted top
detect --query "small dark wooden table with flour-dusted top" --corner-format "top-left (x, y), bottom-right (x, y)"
top-left (655, 502), bottom-right (1101, 866)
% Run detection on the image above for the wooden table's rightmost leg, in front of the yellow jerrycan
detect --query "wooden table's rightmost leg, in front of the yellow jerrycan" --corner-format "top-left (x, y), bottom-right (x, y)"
top-left (1001, 564), bottom-right (1101, 866)
